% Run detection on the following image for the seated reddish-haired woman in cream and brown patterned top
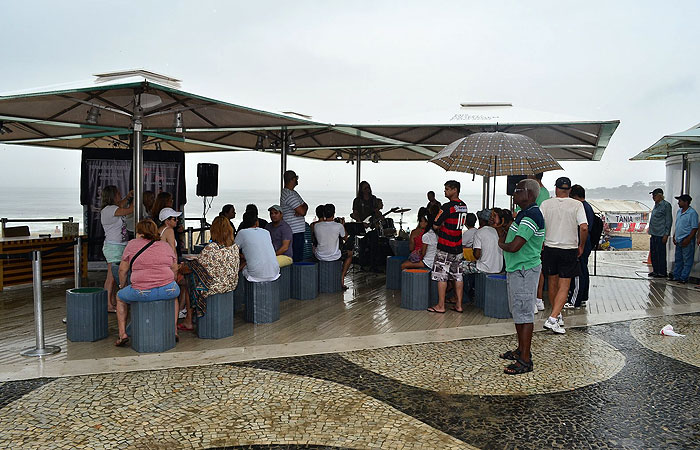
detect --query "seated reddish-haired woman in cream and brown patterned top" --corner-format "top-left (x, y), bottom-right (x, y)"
top-left (177, 216), bottom-right (240, 331)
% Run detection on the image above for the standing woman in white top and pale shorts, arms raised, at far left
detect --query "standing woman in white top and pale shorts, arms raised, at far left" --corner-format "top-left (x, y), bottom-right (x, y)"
top-left (100, 185), bottom-right (134, 312)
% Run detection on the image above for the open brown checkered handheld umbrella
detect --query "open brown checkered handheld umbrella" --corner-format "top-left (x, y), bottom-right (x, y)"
top-left (430, 132), bottom-right (561, 177)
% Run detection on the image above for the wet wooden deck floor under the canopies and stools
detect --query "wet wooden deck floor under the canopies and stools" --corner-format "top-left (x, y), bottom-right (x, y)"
top-left (0, 252), bottom-right (700, 379)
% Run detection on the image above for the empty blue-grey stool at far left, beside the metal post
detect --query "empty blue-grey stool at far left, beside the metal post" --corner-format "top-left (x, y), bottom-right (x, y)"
top-left (66, 288), bottom-right (109, 342)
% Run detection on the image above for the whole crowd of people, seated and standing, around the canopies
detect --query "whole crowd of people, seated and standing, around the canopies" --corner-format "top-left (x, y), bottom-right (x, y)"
top-left (101, 171), bottom-right (698, 374)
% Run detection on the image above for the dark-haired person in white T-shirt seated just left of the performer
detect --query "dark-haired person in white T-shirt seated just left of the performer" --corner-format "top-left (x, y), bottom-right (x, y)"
top-left (314, 203), bottom-right (352, 290)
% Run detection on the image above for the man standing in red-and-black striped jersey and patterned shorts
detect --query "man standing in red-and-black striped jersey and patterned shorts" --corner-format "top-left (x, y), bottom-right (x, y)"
top-left (428, 180), bottom-right (467, 313)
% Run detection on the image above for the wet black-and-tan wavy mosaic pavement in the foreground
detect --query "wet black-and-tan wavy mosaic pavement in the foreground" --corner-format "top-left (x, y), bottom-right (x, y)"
top-left (0, 314), bottom-right (700, 449)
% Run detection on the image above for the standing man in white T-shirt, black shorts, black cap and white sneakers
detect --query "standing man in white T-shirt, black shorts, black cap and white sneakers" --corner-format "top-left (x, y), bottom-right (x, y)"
top-left (540, 177), bottom-right (588, 334)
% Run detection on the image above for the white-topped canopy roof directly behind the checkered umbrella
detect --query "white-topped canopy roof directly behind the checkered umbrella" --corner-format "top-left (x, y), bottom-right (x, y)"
top-left (304, 103), bottom-right (620, 161)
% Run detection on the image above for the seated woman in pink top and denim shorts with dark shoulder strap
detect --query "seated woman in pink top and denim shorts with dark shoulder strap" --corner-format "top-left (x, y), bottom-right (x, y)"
top-left (115, 219), bottom-right (180, 347)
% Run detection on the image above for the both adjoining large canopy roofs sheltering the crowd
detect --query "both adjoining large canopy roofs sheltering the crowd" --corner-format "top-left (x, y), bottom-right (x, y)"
top-left (0, 70), bottom-right (619, 217)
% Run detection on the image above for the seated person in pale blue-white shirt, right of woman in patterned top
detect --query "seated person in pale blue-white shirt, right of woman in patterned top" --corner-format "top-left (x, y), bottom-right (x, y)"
top-left (236, 211), bottom-right (280, 282)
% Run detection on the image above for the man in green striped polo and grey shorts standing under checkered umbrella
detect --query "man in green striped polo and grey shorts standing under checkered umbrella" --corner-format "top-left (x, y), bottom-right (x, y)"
top-left (498, 179), bottom-right (544, 375)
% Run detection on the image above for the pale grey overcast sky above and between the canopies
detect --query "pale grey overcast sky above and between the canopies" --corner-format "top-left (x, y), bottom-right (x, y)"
top-left (0, 0), bottom-right (700, 196)
